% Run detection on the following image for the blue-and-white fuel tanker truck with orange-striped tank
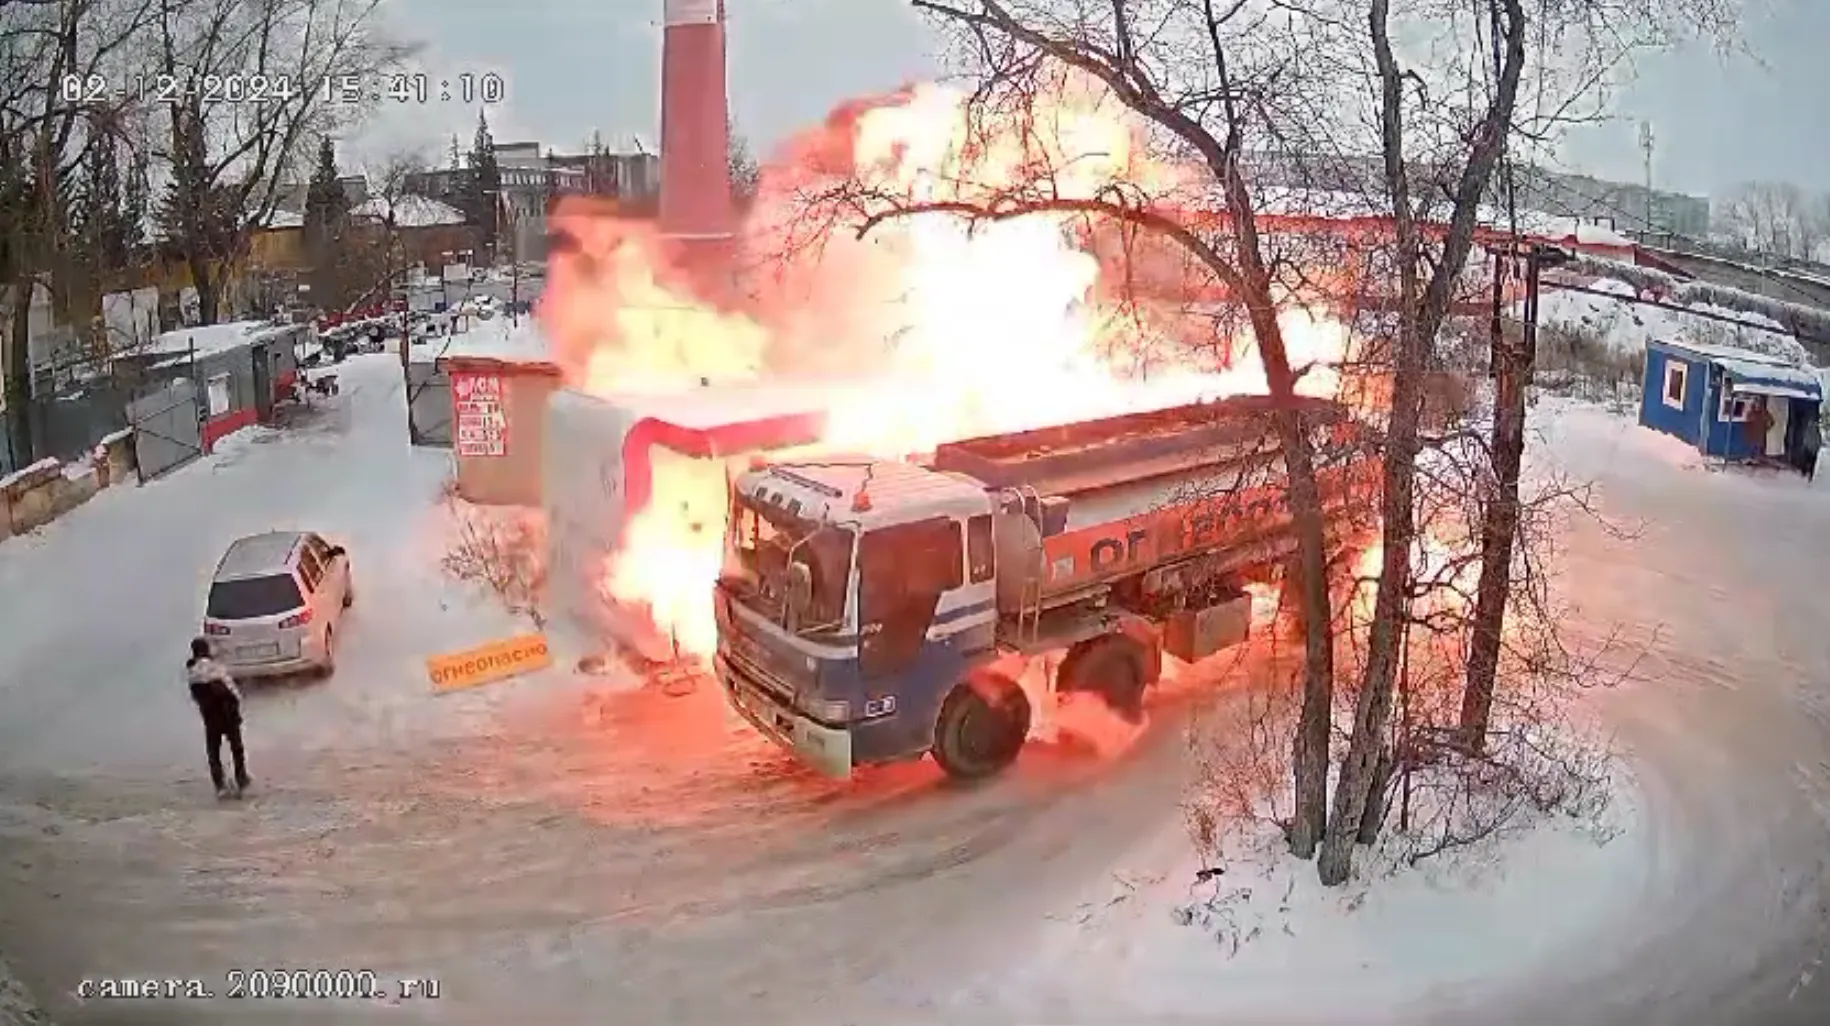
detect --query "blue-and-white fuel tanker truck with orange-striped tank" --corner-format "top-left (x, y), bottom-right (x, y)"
top-left (714, 397), bottom-right (1378, 779)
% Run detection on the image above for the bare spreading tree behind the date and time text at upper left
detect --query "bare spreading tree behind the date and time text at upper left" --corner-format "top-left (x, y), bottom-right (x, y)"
top-left (152, 0), bottom-right (408, 324)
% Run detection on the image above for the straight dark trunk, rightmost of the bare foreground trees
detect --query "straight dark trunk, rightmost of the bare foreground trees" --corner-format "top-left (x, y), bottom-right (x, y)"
top-left (1460, 250), bottom-right (1537, 752)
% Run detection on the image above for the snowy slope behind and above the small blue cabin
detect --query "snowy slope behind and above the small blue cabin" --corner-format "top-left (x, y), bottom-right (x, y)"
top-left (1513, 278), bottom-right (1812, 366)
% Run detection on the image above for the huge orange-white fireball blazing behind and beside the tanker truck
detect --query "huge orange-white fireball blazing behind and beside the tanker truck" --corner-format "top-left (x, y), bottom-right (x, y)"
top-left (542, 79), bottom-right (1349, 657)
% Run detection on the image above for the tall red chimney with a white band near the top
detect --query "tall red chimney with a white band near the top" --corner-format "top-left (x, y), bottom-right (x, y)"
top-left (661, 0), bottom-right (737, 243)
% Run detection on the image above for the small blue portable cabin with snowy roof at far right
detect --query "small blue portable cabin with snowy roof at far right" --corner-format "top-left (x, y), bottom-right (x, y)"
top-left (1640, 340), bottom-right (1823, 463)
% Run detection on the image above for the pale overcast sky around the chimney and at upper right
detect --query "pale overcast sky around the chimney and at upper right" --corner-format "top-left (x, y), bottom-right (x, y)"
top-left (353, 0), bottom-right (1830, 202)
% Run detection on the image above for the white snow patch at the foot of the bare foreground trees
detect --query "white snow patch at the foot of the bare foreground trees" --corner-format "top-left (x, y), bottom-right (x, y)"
top-left (980, 793), bottom-right (1651, 1022)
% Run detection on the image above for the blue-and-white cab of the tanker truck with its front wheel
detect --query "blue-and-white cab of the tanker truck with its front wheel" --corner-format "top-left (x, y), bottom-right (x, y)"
top-left (714, 459), bottom-right (1028, 777)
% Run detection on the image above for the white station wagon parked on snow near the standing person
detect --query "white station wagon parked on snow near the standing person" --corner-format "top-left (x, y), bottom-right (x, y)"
top-left (203, 530), bottom-right (355, 677)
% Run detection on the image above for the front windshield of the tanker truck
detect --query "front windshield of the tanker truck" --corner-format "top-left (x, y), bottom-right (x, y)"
top-left (725, 496), bottom-right (853, 635)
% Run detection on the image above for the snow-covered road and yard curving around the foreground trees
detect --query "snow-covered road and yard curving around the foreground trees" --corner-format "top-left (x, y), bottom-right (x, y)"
top-left (0, 378), bottom-right (1830, 1026)
